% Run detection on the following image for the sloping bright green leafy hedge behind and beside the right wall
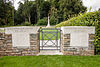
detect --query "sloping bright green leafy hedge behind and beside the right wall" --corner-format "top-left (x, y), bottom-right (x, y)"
top-left (56, 10), bottom-right (100, 54)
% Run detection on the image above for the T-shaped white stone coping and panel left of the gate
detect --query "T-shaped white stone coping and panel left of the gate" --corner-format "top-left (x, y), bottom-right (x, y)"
top-left (5, 26), bottom-right (39, 47)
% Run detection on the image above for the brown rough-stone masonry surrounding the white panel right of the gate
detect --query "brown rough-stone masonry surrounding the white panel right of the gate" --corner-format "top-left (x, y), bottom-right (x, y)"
top-left (62, 34), bottom-right (94, 55)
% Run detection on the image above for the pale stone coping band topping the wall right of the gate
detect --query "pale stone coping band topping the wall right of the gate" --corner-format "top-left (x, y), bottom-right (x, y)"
top-left (61, 26), bottom-right (95, 34)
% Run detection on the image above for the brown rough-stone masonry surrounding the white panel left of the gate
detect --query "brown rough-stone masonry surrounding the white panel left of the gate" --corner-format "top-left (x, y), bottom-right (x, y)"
top-left (0, 33), bottom-right (39, 56)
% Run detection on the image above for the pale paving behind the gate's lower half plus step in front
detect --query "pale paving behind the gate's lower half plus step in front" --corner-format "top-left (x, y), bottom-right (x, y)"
top-left (38, 40), bottom-right (63, 55)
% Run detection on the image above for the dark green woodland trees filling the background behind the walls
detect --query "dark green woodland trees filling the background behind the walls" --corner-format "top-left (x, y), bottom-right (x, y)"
top-left (0, 0), bottom-right (86, 26)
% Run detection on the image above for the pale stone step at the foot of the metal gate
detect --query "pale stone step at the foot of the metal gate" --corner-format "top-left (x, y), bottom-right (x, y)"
top-left (38, 50), bottom-right (63, 55)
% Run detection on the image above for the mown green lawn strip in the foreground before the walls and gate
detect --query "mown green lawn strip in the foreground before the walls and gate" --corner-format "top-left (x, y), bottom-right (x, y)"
top-left (0, 55), bottom-right (100, 67)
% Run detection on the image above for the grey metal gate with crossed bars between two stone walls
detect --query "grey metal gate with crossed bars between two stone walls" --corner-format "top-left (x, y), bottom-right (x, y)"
top-left (39, 28), bottom-right (61, 50)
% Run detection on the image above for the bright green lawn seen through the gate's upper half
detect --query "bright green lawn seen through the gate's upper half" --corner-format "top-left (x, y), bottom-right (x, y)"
top-left (40, 30), bottom-right (60, 40)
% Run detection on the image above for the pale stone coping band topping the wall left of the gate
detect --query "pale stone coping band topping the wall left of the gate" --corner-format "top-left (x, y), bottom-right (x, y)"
top-left (5, 26), bottom-right (40, 34)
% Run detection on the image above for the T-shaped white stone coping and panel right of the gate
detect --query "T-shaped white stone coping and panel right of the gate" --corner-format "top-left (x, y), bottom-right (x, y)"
top-left (61, 26), bottom-right (95, 47)
